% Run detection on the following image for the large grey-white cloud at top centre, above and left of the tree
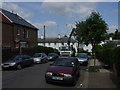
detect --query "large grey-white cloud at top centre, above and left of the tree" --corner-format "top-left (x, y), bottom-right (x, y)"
top-left (42, 2), bottom-right (96, 18)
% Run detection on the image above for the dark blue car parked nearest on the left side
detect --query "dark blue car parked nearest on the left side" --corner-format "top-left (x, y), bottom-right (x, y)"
top-left (2, 55), bottom-right (34, 70)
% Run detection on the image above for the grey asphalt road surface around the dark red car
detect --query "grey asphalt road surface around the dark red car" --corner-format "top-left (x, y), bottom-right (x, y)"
top-left (2, 59), bottom-right (86, 88)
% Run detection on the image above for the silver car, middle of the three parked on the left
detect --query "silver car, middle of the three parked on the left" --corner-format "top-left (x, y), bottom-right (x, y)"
top-left (33, 53), bottom-right (48, 63)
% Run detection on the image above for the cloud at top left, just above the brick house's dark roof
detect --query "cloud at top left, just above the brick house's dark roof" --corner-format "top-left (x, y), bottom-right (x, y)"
top-left (2, 3), bottom-right (34, 18)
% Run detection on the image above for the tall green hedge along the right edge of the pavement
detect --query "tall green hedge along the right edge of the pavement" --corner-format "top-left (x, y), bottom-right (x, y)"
top-left (96, 45), bottom-right (120, 75)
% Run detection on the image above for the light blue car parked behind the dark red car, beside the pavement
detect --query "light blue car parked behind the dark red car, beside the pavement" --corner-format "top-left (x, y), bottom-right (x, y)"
top-left (76, 53), bottom-right (89, 66)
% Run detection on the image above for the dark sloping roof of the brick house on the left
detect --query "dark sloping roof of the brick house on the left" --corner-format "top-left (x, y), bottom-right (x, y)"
top-left (0, 8), bottom-right (38, 30)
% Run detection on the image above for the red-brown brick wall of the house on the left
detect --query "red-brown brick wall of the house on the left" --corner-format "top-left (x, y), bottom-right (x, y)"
top-left (0, 13), bottom-right (37, 47)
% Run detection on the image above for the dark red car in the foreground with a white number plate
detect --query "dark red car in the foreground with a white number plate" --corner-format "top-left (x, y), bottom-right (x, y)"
top-left (45, 57), bottom-right (80, 85)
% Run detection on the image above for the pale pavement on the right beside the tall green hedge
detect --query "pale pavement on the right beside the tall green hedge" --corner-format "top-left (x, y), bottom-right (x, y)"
top-left (82, 59), bottom-right (118, 88)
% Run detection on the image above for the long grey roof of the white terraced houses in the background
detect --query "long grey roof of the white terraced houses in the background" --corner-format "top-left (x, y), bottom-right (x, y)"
top-left (38, 37), bottom-right (76, 43)
